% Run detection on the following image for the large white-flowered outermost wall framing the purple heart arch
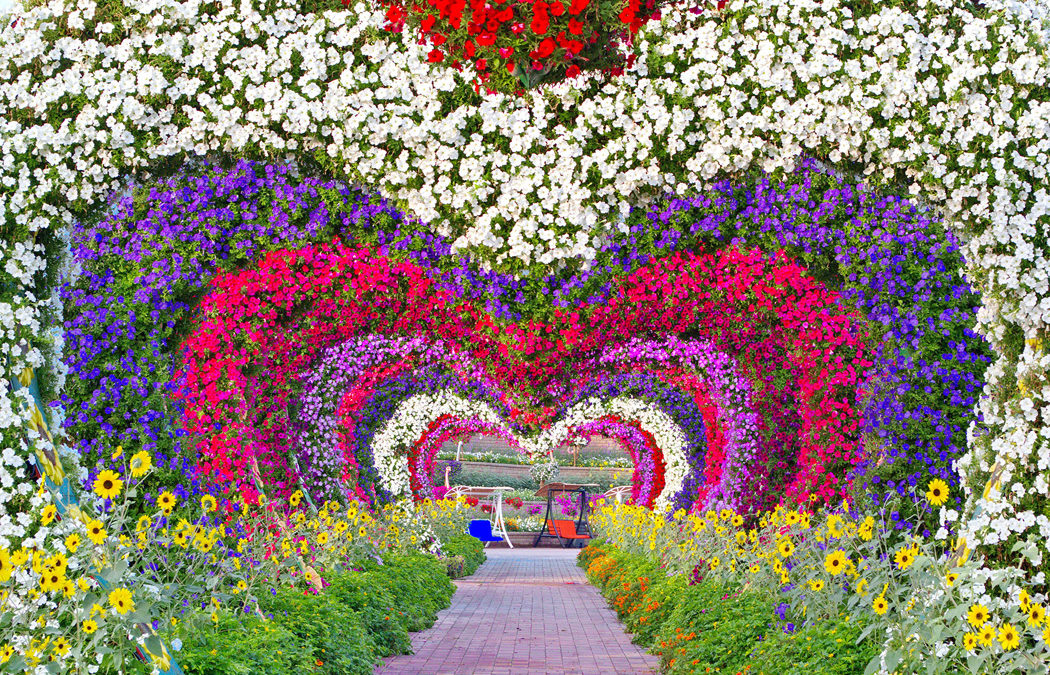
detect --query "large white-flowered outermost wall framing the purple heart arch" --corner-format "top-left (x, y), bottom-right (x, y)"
top-left (0, 0), bottom-right (1050, 571)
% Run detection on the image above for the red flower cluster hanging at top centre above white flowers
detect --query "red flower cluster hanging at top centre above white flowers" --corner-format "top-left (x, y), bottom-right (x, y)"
top-left (375, 0), bottom-right (659, 92)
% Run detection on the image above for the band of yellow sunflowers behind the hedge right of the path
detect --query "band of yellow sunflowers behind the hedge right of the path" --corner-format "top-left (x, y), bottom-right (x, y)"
top-left (591, 480), bottom-right (1050, 668)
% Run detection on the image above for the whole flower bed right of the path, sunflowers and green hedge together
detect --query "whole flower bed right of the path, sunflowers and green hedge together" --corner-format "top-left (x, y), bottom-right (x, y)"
top-left (580, 501), bottom-right (1050, 674)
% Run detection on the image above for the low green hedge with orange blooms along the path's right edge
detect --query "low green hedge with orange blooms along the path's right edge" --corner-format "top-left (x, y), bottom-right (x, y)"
top-left (579, 542), bottom-right (879, 675)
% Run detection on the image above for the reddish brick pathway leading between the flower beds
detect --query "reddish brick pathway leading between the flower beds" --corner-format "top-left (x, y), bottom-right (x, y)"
top-left (377, 548), bottom-right (659, 675)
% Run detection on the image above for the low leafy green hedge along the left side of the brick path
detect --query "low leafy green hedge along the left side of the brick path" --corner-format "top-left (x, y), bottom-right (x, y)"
top-left (172, 554), bottom-right (459, 675)
